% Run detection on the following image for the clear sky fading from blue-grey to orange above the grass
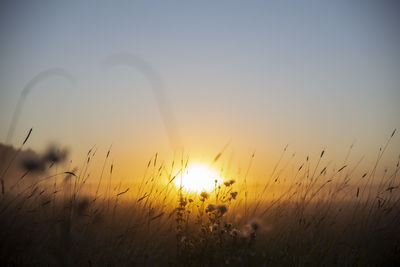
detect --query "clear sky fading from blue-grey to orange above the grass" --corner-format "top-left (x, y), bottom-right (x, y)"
top-left (0, 1), bottom-right (400, 181)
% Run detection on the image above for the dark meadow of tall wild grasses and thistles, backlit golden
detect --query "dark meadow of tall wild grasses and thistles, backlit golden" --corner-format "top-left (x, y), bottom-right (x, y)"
top-left (0, 131), bottom-right (400, 266)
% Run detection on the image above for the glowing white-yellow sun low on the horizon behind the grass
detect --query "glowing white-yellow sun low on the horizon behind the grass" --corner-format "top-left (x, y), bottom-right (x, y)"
top-left (174, 163), bottom-right (222, 192)
